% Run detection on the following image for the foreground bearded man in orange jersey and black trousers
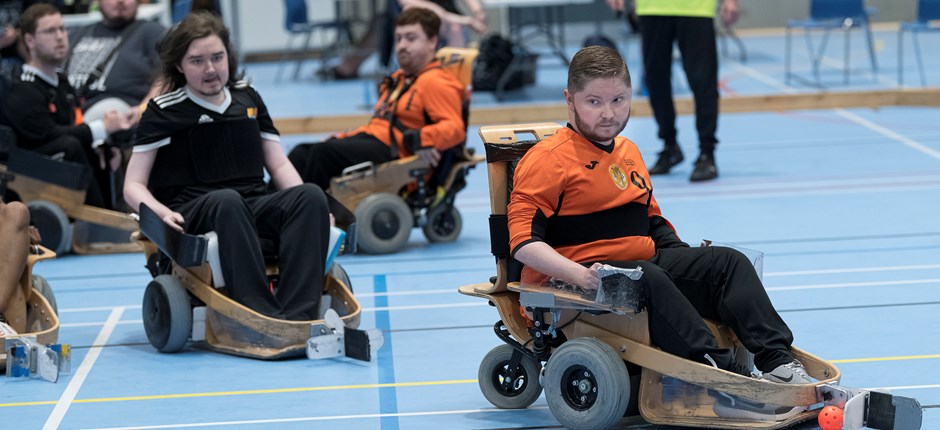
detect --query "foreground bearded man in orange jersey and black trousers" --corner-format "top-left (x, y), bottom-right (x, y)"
top-left (508, 46), bottom-right (811, 413)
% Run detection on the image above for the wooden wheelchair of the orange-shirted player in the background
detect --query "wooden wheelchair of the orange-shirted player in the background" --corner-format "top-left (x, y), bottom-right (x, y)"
top-left (329, 47), bottom-right (485, 254)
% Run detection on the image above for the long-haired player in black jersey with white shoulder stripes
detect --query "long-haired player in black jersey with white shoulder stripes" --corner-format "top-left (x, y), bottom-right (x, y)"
top-left (124, 12), bottom-right (330, 320)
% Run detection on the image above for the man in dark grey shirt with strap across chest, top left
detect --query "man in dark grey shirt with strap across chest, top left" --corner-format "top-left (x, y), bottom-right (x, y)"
top-left (65, 0), bottom-right (165, 112)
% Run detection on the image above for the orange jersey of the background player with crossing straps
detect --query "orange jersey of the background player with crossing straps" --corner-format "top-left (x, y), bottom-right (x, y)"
top-left (345, 60), bottom-right (466, 157)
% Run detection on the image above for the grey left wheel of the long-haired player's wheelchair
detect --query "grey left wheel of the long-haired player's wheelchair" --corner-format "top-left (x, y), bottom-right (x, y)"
top-left (143, 275), bottom-right (193, 352)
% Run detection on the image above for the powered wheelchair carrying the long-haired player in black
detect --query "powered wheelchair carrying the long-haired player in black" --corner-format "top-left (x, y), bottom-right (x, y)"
top-left (133, 119), bottom-right (371, 360)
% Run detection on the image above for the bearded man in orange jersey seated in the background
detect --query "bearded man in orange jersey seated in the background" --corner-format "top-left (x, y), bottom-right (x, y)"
top-left (289, 8), bottom-right (466, 189)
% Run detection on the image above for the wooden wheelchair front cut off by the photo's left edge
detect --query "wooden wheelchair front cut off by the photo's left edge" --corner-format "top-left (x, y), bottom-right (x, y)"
top-left (0, 246), bottom-right (59, 369)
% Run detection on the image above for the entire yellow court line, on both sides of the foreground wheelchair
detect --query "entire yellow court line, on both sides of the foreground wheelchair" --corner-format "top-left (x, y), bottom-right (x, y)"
top-left (0, 354), bottom-right (940, 408)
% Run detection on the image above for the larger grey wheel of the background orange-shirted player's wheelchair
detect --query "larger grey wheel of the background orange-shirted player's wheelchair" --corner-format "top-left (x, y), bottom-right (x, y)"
top-left (356, 193), bottom-right (414, 254)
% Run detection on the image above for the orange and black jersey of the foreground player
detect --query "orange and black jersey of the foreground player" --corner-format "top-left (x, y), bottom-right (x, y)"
top-left (509, 128), bottom-right (662, 279)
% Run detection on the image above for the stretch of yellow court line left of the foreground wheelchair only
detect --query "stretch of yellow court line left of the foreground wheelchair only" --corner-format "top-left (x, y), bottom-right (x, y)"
top-left (0, 379), bottom-right (477, 408)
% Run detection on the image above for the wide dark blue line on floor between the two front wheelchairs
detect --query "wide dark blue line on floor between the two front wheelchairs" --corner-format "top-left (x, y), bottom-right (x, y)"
top-left (373, 274), bottom-right (398, 430)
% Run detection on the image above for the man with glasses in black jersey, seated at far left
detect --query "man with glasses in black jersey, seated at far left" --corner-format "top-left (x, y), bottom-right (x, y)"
top-left (2, 3), bottom-right (137, 207)
